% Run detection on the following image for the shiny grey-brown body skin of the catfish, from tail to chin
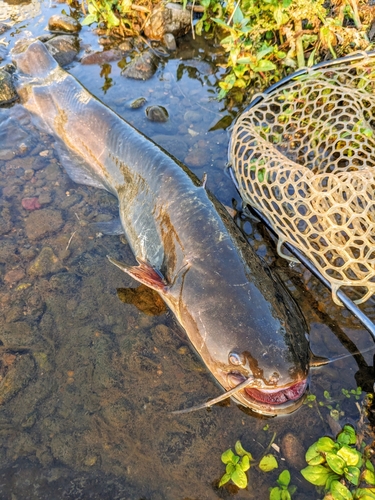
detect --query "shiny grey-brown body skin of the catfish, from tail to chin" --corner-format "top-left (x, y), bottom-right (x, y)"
top-left (13, 41), bottom-right (309, 416)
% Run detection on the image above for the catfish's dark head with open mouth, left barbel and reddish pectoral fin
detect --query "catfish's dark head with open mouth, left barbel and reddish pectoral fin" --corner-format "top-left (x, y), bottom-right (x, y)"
top-left (110, 250), bottom-right (310, 416)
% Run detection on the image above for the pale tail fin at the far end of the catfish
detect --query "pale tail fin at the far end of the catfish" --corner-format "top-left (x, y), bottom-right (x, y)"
top-left (12, 40), bottom-right (58, 78)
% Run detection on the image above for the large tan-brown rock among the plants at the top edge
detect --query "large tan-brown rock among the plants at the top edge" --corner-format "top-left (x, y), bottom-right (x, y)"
top-left (144, 3), bottom-right (191, 41)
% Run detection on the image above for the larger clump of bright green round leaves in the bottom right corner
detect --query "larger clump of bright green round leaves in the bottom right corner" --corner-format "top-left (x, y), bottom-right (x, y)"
top-left (301, 425), bottom-right (375, 500)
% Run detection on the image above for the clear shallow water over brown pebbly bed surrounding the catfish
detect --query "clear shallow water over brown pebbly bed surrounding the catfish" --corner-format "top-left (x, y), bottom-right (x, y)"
top-left (0, 3), bottom-right (375, 500)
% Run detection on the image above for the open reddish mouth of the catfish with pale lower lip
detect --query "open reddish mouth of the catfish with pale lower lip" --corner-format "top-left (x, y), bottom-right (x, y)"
top-left (228, 372), bottom-right (308, 415)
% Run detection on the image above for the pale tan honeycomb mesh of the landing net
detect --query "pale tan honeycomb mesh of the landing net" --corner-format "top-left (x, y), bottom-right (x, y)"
top-left (229, 54), bottom-right (375, 304)
